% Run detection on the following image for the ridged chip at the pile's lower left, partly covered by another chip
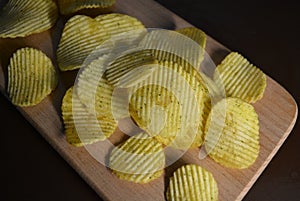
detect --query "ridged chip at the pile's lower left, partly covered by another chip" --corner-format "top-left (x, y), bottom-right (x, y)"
top-left (62, 87), bottom-right (117, 147)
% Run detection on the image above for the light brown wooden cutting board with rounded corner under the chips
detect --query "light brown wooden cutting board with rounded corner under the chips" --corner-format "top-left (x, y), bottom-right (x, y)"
top-left (0, 0), bottom-right (297, 201)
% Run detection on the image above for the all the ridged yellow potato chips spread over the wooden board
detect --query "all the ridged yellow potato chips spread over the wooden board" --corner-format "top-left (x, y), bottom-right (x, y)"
top-left (0, 0), bottom-right (266, 200)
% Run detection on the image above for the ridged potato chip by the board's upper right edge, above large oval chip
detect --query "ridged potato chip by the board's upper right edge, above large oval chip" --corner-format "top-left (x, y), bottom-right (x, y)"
top-left (214, 52), bottom-right (267, 103)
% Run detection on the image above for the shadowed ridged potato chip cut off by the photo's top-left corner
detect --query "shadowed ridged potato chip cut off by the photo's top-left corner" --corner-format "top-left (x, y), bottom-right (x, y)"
top-left (0, 0), bottom-right (58, 38)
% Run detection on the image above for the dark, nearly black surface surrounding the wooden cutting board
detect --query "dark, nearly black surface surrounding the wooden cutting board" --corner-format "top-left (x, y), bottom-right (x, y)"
top-left (0, 0), bottom-right (300, 201)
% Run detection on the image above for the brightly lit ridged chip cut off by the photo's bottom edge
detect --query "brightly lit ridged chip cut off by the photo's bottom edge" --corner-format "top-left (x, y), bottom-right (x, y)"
top-left (166, 164), bottom-right (219, 201)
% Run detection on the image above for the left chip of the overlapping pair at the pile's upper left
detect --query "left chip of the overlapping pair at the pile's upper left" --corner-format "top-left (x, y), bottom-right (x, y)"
top-left (57, 15), bottom-right (109, 71)
